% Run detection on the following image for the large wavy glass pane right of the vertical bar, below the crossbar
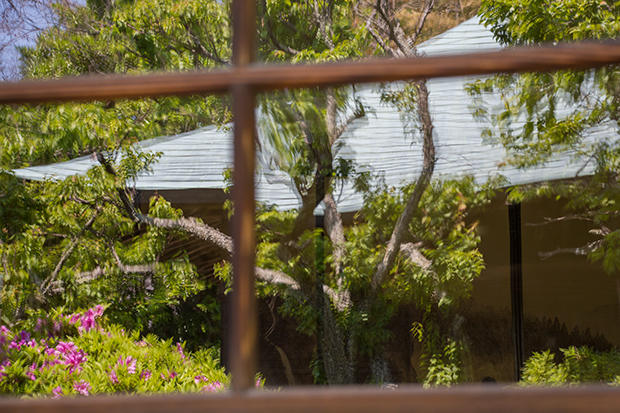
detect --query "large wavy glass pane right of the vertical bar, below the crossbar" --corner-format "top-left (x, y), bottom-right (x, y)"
top-left (256, 54), bottom-right (618, 385)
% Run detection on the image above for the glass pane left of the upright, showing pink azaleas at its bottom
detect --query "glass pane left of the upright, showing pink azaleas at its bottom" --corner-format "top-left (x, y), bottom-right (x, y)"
top-left (0, 96), bottom-right (233, 396)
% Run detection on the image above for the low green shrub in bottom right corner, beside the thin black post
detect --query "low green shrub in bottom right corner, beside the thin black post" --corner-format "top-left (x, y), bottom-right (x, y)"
top-left (522, 347), bottom-right (620, 386)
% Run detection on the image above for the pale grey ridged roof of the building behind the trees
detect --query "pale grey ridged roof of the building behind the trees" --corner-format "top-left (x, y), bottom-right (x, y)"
top-left (10, 18), bottom-right (613, 214)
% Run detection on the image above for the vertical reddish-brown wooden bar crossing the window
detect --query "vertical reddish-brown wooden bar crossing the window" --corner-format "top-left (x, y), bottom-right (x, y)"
top-left (228, 0), bottom-right (258, 392)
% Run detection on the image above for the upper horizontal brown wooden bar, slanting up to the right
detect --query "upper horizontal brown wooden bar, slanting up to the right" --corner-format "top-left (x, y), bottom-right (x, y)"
top-left (0, 42), bottom-right (620, 104)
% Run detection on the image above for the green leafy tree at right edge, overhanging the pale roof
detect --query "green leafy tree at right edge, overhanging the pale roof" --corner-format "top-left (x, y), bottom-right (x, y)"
top-left (470, 0), bottom-right (620, 273)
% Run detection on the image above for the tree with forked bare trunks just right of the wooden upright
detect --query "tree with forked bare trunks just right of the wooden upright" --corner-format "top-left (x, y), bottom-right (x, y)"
top-left (228, 1), bottom-right (490, 384)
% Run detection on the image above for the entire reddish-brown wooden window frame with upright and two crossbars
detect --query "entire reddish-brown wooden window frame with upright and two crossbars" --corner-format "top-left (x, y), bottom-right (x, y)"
top-left (0, 0), bottom-right (620, 413)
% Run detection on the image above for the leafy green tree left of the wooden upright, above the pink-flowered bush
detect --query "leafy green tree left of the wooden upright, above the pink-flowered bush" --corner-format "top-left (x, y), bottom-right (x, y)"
top-left (0, 1), bottom-right (235, 347)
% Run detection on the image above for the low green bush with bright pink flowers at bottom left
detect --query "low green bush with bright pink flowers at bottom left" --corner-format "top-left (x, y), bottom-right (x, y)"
top-left (0, 306), bottom-right (248, 397)
